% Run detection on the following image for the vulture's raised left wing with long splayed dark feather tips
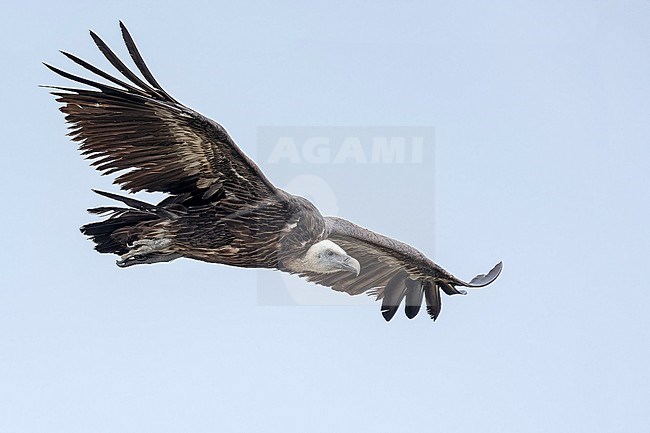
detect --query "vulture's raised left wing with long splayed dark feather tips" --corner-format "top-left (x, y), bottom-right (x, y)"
top-left (45, 22), bottom-right (277, 200)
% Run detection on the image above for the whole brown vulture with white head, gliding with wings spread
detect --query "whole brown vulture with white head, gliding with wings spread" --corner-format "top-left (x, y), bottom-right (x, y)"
top-left (45, 22), bottom-right (502, 321)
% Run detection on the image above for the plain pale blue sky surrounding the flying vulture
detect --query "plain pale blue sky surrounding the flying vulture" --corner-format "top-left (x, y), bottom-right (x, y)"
top-left (0, 1), bottom-right (650, 433)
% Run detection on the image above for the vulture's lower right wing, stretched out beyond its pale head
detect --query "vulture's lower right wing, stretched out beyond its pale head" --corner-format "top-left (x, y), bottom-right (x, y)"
top-left (303, 217), bottom-right (503, 320)
